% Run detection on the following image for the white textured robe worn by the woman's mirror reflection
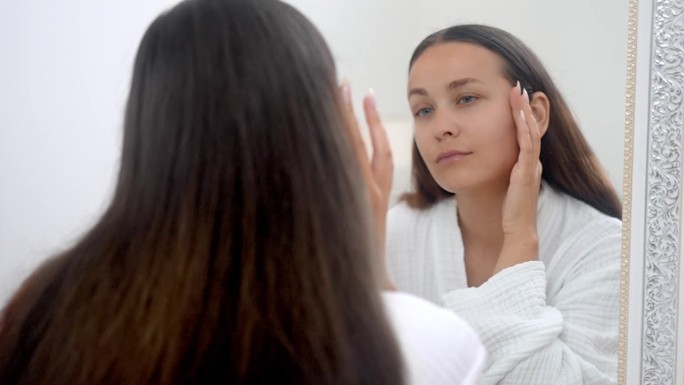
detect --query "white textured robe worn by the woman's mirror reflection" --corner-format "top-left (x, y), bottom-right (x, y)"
top-left (387, 183), bottom-right (621, 384)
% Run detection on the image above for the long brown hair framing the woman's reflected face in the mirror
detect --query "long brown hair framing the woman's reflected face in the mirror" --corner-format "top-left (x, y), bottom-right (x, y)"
top-left (402, 24), bottom-right (622, 218)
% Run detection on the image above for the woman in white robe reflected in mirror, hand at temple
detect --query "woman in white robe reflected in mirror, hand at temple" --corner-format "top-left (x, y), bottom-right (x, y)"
top-left (387, 25), bottom-right (621, 384)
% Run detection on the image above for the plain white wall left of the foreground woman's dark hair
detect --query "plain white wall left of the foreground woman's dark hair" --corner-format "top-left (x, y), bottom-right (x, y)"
top-left (0, 0), bottom-right (176, 304)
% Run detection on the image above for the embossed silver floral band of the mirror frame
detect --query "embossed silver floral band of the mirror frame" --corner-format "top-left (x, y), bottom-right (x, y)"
top-left (642, 0), bottom-right (684, 384)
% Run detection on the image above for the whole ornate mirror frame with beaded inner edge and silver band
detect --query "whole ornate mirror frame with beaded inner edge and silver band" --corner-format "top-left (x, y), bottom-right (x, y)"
top-left (618, 0), bottom-right (684, 385)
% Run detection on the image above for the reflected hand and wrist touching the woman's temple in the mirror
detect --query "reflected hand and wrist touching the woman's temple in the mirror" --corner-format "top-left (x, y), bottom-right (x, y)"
top-left (494, 83), bottom-right (542, 274)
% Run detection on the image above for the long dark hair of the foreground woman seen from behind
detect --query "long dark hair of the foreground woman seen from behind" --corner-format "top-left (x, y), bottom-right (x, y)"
top-left (0, 0), bottom-right (403, 385)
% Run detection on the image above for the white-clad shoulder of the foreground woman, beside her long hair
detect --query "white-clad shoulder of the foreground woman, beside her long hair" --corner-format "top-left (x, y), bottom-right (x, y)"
top-left (382, 292), bottom-right (486, 385)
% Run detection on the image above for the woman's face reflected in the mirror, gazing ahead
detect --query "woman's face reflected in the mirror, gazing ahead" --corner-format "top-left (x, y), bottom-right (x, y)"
top-left (408, 42), bottom-right (519, 193)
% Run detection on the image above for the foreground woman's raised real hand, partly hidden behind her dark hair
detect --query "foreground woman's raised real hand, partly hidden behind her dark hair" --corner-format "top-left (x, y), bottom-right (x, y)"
top-left (341, 81), bottom-right (396, 290)
